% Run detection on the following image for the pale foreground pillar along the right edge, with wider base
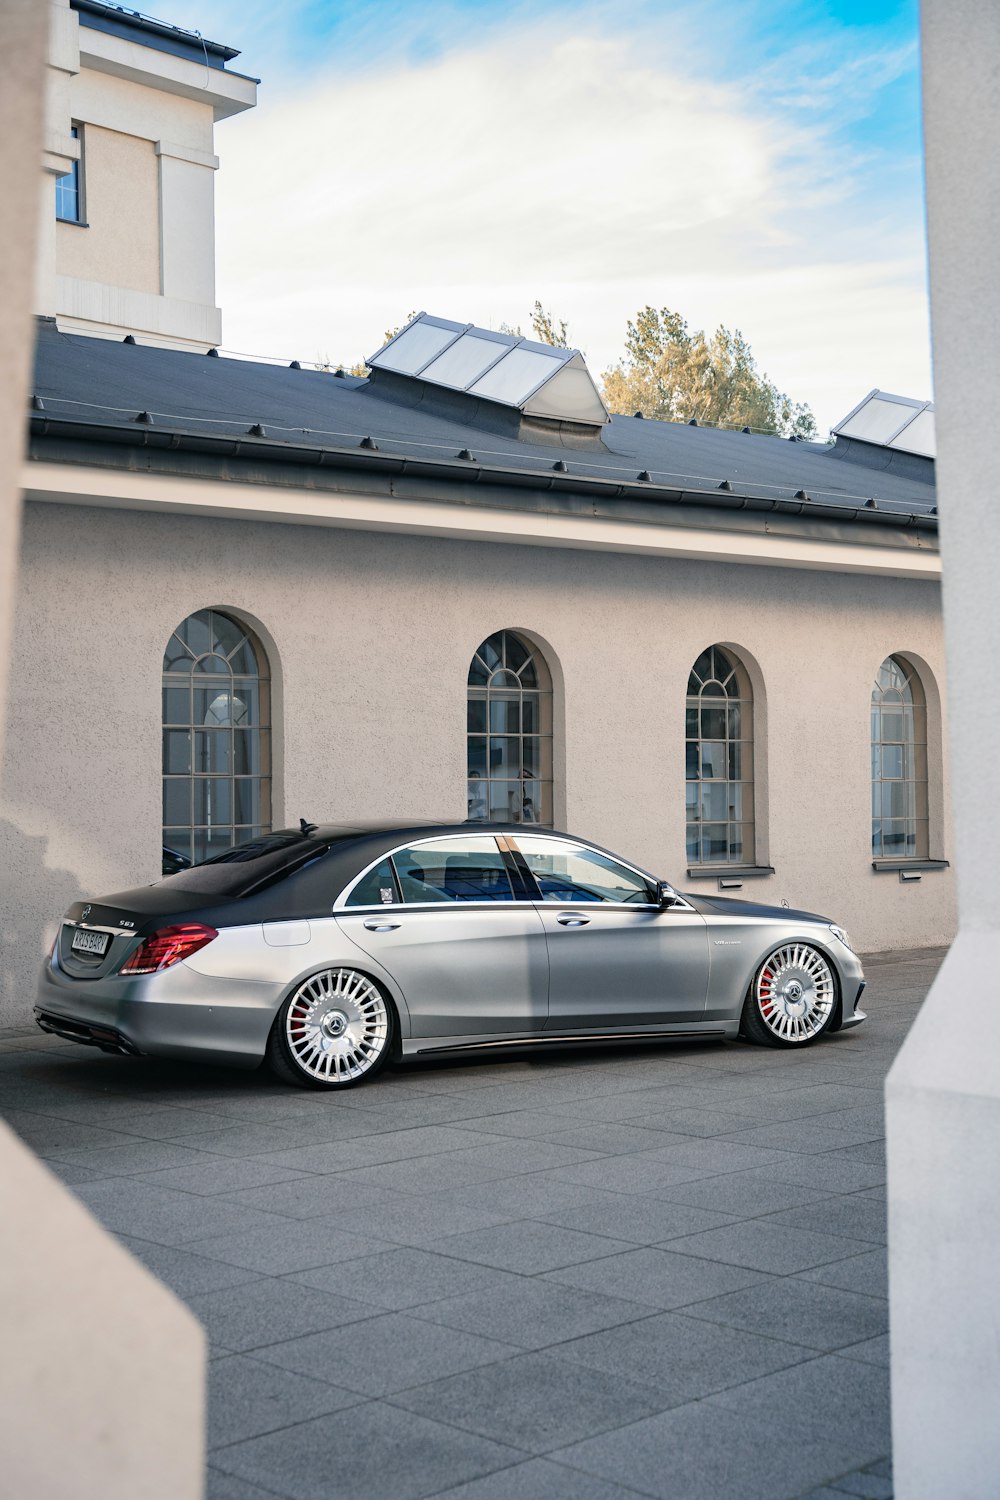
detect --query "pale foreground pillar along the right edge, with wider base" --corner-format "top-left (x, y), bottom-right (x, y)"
top-left (886, 0), bottom-right (1000, 1500)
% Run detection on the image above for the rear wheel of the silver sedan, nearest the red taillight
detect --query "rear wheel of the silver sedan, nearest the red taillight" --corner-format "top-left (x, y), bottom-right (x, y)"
top-left (267, 969), bottom-right (396, 1089)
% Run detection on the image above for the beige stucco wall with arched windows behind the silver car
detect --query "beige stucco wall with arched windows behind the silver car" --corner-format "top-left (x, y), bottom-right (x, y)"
top-left (0, 504), bottom-right (954, 1020)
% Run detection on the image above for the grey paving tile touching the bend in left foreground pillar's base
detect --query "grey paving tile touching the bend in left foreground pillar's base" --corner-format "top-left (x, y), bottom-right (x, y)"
top-left (187, 1277), bottom-right (376, 1353)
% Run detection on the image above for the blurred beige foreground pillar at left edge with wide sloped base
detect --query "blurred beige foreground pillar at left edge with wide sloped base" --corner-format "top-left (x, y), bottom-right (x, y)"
top-left (0, 0), bottom-right (205, 1500)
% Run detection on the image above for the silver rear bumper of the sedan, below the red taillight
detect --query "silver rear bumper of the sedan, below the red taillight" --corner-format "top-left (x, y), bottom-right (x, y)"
top-left (34, 962), bottom-right (282, 1068)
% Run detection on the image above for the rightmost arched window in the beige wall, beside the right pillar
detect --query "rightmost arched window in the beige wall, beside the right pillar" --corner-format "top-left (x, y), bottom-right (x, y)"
top-left (871, 657), bottom-right (928, 860)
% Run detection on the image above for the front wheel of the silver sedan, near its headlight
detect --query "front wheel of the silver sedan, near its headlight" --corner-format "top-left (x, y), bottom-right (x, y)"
top-left (741, 942), bottom-right (837, 1047)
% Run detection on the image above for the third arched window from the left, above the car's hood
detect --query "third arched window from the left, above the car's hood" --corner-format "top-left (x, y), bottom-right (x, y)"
top-left (685, 647), bottom-right (756, 864)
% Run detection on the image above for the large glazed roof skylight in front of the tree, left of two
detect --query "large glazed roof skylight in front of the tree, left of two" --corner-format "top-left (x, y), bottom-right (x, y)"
top-left (369, 312), bottom-right (610, 428)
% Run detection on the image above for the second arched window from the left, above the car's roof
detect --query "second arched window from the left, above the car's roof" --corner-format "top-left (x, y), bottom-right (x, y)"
top-left (468, 630), bottom-right (552, 825)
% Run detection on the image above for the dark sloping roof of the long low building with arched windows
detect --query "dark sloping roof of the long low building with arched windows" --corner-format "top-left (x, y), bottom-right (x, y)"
top-left (31, 320), bottom-right (937, 530)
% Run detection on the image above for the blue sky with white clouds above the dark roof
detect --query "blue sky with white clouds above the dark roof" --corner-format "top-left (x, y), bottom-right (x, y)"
top-left (162, 0), bottom-right (931, 428)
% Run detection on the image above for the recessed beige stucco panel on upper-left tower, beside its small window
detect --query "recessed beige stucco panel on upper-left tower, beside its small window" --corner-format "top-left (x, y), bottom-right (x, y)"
top-left (55, 125), bottom-right (160, 293)
